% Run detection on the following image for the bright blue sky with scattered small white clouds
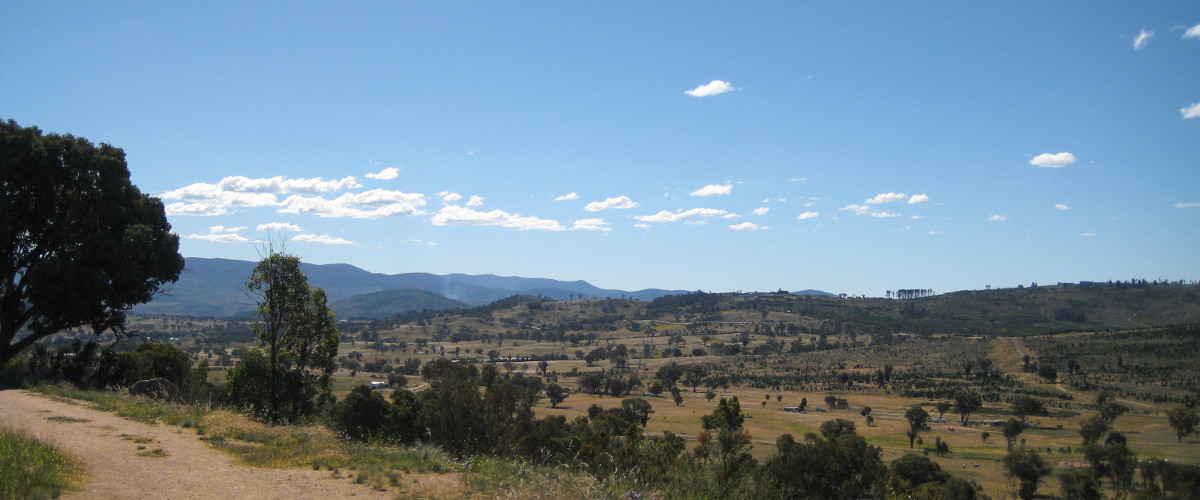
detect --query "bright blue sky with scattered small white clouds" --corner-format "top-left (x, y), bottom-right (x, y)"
top-left (0, 0), bottom-right (1200, 296)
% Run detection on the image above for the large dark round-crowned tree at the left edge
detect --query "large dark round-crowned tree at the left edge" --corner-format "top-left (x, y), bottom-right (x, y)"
top-left (0, 120), bottom-right (184, 367)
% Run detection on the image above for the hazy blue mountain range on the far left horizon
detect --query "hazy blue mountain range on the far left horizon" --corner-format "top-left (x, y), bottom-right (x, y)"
top-left (133, 257), bottom-right (686, 318)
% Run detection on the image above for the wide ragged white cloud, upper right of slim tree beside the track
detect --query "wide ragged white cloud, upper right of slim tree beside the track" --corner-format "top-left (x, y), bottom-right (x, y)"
top-left (278, 189), bottom-right (426, 218)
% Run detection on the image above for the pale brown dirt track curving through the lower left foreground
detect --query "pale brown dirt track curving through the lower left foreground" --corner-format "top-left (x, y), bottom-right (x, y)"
top-left (0, 390), bottom-right (395, 500)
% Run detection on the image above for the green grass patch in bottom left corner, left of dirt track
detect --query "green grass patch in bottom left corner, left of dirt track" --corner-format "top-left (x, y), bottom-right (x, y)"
top-left (0, 427), bottom-right (83, 499)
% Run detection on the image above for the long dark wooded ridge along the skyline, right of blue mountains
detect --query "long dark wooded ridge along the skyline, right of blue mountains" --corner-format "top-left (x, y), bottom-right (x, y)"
top-left (374, 284), bottom-right (1200, 336)
